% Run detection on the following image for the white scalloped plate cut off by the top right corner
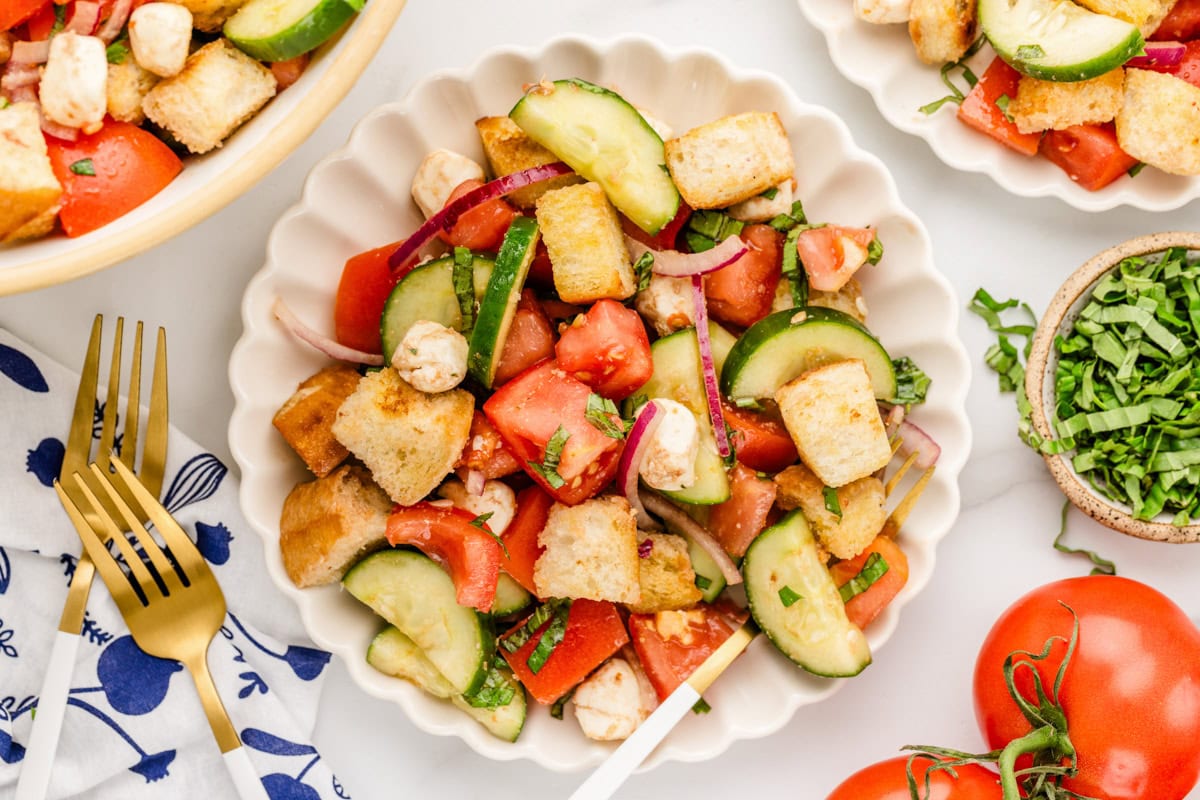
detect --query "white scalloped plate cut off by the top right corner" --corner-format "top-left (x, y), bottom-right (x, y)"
top-left (798, 0), bottom-right (1200, 211)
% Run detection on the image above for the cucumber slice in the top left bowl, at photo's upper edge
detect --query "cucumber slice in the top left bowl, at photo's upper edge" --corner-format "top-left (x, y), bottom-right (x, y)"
top-left (224, 0), bottom-right (362, 61)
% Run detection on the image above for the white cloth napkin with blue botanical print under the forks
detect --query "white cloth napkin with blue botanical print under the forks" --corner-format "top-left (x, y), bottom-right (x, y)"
top-left (0, 329), bottom-right (349, 800)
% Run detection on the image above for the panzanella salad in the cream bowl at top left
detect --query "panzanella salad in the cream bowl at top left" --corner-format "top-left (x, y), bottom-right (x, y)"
top-left (0, 0), bottom-right (365, 242)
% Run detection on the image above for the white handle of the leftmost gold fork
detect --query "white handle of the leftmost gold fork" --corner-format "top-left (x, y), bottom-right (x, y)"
top-left (16, 631), bottom-right (79, 800)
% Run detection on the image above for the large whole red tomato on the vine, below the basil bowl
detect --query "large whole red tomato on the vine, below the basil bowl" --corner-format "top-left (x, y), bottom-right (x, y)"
top-left (974, 576), bottom-right (1200, 800)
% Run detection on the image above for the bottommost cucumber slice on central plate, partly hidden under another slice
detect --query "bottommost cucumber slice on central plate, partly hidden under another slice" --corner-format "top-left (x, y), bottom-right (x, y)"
top-left (367, 625), bottom-right (526, 741)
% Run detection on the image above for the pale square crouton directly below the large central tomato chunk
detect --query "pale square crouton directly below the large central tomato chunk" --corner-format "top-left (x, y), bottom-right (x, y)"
top-left (533, 494), bottom-right (641, 603)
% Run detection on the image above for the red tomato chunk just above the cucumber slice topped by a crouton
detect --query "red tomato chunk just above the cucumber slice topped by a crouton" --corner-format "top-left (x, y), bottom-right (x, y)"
top-left (704, 225), bottom-right (784, 327)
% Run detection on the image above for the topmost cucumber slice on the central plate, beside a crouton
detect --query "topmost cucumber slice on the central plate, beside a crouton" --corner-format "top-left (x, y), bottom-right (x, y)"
top-left (509, 78), bottom-right (679, 234)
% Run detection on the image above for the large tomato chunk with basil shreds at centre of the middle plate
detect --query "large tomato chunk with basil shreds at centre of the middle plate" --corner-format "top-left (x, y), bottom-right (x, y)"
top-left (484, 361), bottom-right (620, 505)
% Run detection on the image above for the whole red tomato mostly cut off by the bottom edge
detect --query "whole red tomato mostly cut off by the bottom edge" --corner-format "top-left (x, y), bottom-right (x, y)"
top-left (826, 756), bottom-right (1001, 800)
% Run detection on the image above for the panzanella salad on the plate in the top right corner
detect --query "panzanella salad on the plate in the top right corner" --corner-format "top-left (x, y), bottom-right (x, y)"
top-left (853, 0), bottom-right (1200, 191)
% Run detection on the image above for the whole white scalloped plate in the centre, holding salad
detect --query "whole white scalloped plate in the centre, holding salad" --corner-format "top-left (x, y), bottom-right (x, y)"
top-left (229, 38), bottom-right (971, 770)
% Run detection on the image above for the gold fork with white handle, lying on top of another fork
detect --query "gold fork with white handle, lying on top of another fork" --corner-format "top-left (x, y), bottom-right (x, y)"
top-left (54, 461), bottom-right (266, 800)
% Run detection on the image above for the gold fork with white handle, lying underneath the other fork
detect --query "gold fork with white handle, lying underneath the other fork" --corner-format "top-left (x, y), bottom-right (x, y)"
top-left (16, 314), bottom-right (168, 800)
